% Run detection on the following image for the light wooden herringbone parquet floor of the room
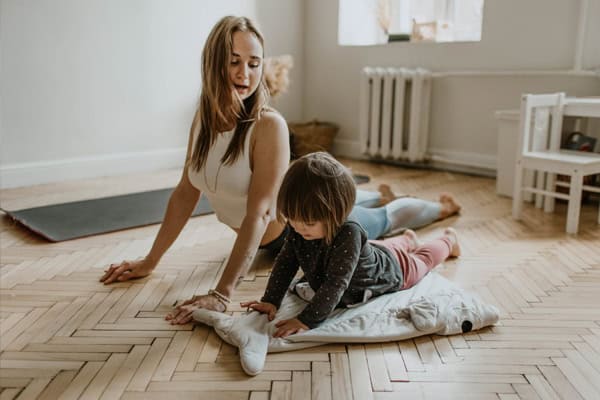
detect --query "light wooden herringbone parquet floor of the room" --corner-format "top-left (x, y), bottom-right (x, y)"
top-left (0, 162), bottom-right (600, 400)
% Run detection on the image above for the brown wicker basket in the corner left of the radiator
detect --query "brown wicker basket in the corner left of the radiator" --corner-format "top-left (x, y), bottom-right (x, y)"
top-left (288, 119), bottom-right (339, 157)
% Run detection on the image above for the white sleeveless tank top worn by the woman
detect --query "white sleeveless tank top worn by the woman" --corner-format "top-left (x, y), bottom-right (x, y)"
top-left (188, 124), bottom-right (254, 228)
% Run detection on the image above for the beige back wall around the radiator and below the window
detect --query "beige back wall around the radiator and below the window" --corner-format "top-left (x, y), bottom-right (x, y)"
top-left (304, 0), bottom-right (600, 170)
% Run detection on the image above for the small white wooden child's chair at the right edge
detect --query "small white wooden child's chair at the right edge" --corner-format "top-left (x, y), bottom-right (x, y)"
top-left (512, 93), bottom-right (600, 233)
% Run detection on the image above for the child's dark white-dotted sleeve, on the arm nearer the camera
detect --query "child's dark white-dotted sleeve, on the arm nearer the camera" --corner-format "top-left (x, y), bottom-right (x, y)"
top-left (298, 224), bottom-right (362, 328)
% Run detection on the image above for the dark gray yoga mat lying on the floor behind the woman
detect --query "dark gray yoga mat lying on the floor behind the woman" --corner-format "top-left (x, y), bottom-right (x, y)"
top-left (2, 188), bottom-right (213, 242)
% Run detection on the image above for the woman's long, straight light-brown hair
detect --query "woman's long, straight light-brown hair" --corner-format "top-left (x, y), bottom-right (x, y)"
top-left (187, 16), bottom-right (269, 170)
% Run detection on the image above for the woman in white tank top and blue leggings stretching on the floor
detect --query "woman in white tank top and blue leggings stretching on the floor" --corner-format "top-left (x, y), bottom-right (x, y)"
top-left (100, 16), bottom-right (457, 323)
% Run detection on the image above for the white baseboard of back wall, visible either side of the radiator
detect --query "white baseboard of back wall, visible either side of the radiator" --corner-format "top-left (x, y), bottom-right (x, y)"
top-left (333, 139), bottom-right (496, 176)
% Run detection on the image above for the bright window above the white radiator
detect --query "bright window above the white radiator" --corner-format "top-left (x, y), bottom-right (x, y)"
top-left (338, 0), bottom-right (483, 46)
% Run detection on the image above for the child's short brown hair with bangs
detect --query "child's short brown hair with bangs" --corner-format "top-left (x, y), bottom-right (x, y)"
top-left (277, 152), bottom-right (356, 244)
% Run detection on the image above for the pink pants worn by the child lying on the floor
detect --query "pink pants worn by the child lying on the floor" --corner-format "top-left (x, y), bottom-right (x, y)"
top-left (369, 235), bottom-right (452, 290)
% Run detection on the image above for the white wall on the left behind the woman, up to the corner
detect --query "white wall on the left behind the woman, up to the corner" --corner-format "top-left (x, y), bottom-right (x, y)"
top-left (0, 0), bottom-right (303, 187)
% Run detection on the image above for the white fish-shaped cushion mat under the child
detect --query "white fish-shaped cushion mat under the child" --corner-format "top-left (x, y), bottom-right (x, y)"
top-left (193, 272), bottom-right (499, 375)
